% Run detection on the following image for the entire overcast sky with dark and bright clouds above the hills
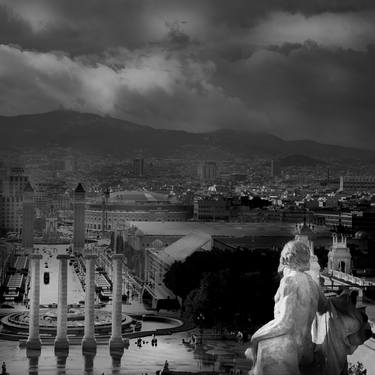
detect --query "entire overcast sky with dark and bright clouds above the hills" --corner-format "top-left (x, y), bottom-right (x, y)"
top-left (0, 0), bottom-right (375, 149)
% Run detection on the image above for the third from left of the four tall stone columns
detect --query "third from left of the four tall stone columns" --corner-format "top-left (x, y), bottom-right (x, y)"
top-left (82, 254), bottom-right (98, 352)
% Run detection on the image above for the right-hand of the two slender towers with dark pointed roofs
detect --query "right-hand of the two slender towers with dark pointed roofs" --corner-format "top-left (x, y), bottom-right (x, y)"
top-left (73, 183), bottom-right (86, 254)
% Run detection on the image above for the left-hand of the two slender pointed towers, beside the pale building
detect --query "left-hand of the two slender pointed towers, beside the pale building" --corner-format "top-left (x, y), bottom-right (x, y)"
top-left (22, 183), bottom-right (35, 253)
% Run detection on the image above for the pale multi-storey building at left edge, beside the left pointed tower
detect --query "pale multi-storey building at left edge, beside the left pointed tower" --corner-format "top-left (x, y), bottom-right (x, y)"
top-left (0, 167), bottom-right (29, 234)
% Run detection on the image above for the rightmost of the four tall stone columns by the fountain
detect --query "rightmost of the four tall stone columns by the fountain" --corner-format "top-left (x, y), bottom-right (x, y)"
top-left (109, 254), bottom-right (124, 351)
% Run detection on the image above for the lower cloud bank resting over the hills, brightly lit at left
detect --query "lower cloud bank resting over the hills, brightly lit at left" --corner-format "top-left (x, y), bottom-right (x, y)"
top-left (0, 42), bottom-right (375, 147)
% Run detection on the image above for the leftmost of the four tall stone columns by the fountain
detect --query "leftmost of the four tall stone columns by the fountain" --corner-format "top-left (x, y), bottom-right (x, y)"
top-left (26, 254), bottom-right (43, 350)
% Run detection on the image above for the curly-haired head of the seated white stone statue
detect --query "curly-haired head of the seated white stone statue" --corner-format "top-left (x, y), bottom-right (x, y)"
top-left (278, 241), bottom-right (310, 272)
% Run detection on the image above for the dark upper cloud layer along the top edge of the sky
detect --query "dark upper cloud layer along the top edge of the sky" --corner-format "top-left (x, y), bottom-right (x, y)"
top-left (0, 0), bottom-right (375, 55)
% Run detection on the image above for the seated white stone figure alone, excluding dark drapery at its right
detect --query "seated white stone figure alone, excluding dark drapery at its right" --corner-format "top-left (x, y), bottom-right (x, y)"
top-left (245, 241), bottom-right (322, 375)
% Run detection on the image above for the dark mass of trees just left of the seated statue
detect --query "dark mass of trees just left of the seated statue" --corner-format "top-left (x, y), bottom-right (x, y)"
top-left (164, 249), bottom-right (280, 330)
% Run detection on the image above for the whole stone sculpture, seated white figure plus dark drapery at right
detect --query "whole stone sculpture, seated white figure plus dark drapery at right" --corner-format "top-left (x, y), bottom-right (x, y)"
top-left (245, 241), bottom-right (370, 375)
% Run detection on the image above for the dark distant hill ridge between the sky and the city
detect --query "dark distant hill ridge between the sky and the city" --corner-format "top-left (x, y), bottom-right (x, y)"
top-left (0, 111), bottom-right (375, 162)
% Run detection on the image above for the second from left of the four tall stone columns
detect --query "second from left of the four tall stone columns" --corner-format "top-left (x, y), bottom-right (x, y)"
top-left (55, 254), bottom-right (69, 352)
